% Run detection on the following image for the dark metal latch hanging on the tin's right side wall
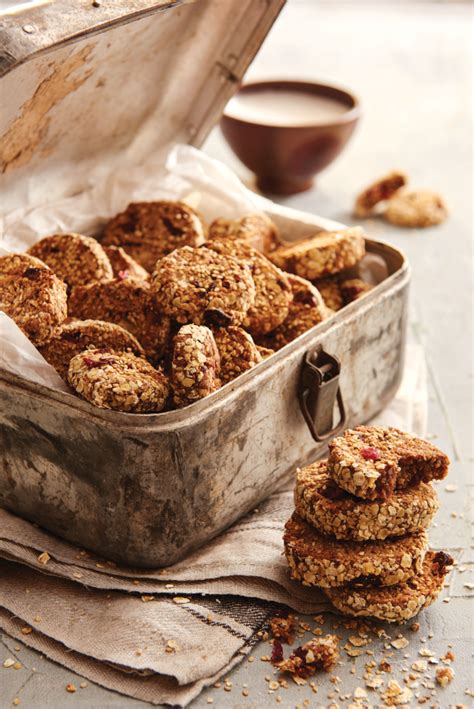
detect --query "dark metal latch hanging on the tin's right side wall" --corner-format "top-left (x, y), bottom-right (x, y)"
top-left (299, 348), bottom-right (346, 443)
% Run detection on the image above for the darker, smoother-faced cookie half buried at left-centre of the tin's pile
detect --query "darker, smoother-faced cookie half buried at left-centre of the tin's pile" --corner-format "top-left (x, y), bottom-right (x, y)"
top-left (68, 278), bottom-right (170, 362)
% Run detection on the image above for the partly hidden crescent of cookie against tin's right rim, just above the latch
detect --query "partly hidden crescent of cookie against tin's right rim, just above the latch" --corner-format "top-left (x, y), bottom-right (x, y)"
top-left (262, 275), bottom-right (328, 350)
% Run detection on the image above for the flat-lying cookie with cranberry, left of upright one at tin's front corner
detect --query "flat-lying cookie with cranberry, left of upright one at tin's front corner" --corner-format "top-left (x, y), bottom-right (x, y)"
top-left (68, 348), bottom-right (169, 414)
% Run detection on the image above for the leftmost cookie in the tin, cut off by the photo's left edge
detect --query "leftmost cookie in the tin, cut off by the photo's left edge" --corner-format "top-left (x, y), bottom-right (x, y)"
top-left (0, 254), bottom-right (67, 345)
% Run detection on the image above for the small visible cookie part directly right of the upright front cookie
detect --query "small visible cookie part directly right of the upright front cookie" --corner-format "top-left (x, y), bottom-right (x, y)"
top-left (213, 325), bottom-right (263, 384)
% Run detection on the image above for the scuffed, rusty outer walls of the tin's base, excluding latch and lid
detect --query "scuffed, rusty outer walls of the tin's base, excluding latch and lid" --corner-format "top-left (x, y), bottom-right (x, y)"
top-left (0, 243), bottom-right (409, 566)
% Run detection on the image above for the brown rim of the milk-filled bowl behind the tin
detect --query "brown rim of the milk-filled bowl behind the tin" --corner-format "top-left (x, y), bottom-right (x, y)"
top-left (222, 79), bottom-right (361, 131)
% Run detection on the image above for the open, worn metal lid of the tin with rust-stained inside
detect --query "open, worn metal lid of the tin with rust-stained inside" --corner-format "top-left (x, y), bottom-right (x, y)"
top-left (0, 0), bottom-right (285, 213)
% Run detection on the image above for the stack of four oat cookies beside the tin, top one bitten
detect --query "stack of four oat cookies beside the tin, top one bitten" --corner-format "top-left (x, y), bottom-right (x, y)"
top-left (284, 426), bottom-right (453, 622)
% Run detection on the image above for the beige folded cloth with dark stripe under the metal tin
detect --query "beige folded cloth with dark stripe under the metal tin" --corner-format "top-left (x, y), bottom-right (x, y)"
top-left (0, 347), bottom-right (426, 706)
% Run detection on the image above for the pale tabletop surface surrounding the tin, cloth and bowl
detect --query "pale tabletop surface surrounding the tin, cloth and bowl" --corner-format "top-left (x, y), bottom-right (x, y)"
top-left (0, 0), bottom-right (474, 709)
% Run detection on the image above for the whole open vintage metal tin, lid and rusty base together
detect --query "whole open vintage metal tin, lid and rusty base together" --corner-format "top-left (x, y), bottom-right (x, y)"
top-left (0, 0), bottom-right (409, 566)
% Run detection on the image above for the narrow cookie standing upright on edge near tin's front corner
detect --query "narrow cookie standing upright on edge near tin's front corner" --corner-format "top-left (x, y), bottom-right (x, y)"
top-left (171, 325), bottom-right (221, 407)
